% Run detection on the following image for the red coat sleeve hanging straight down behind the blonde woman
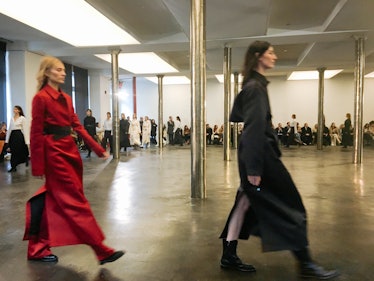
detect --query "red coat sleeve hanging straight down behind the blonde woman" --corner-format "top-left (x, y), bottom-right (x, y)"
top-left (30, 94), bottom-right (46, 176)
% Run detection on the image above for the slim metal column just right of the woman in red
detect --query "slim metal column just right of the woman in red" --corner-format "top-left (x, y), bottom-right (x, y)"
top-left (111, 49), bottom-right (121, 159)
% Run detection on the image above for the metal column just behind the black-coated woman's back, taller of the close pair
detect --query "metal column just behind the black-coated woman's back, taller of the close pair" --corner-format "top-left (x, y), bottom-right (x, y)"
top-left (223, 46), bottom-right (231, 161)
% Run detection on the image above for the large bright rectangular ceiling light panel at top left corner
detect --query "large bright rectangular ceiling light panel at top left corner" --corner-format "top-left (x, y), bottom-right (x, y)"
top-left (0, 0), bottom-right (139, 47)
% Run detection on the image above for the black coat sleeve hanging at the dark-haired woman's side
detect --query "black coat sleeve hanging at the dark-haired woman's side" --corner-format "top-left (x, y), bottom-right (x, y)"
top-left (240, 83), bottom-right (267, 176)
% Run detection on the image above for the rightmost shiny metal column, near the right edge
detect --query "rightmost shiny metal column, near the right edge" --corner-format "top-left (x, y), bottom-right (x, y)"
top-left (353, 37), bottom-right (365, 164)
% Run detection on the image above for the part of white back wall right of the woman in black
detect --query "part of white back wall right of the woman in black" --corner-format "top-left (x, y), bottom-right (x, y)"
top-left (268, 75), bottom-right (374, 126)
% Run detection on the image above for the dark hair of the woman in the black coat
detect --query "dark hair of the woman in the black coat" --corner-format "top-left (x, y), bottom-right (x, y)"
top-left (242, 41), bottom-right (271, 87)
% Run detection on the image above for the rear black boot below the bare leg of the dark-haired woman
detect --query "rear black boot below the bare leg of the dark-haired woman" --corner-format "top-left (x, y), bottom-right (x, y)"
top-left (221, 239), bottom-right (256, 272)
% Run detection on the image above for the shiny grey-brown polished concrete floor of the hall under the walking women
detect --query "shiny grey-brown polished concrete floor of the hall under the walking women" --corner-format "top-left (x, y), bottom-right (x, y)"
top-left (0, 146), bottom-right (374, 281)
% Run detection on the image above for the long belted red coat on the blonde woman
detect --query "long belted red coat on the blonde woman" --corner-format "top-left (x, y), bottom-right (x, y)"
top-left (24, 85), bottom-right (104, 247)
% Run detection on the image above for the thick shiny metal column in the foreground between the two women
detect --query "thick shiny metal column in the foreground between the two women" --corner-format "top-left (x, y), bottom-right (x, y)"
top-left (190, 0), bottom-right (206, 198)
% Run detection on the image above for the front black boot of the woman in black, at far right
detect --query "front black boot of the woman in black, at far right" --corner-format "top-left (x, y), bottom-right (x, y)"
top-left (293, 248), bottom-right (339, 280)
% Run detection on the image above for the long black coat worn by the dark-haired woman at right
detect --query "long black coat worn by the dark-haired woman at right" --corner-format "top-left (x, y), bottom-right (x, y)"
top-left (220, 73), bottom-right (308, 251)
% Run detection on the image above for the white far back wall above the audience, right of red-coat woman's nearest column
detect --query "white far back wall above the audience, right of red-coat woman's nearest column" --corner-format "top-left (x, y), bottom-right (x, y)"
top-left (113, 75), bottom-right (374, 127)
